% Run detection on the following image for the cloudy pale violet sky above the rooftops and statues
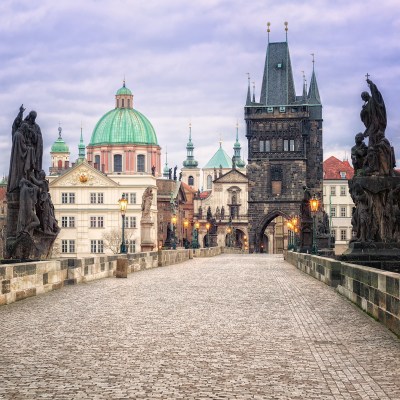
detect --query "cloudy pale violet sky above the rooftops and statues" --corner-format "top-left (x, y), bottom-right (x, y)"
top-left (0, 0), bottom-right (400, 176)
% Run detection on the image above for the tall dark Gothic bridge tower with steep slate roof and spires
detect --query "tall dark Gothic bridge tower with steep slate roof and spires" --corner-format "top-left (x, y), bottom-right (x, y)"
top-left (244, 24), bottom-right (323, 252)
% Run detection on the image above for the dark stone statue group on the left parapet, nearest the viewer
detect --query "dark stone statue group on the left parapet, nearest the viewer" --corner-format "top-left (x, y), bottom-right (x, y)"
top-left (4, 105), bottom-right (60, 260)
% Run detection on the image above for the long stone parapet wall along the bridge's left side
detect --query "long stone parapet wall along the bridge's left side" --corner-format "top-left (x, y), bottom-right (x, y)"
top-left (0, 247), bottom-right (222, 305)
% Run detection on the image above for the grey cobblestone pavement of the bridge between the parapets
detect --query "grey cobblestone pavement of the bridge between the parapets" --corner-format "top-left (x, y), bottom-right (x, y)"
top-left (0, 255), bottom-right (400, 400)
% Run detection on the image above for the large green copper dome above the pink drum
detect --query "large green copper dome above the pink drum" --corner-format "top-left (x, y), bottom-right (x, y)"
top-left (89, 108), bottom-right (158, 146)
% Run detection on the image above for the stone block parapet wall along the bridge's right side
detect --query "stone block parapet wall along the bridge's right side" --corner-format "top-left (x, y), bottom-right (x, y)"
top-left (284, 251), bottom-right (400, 335)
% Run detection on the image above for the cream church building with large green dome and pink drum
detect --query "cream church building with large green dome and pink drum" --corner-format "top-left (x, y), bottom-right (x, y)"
top-left (49, 82), bottom-right (161, 257)
